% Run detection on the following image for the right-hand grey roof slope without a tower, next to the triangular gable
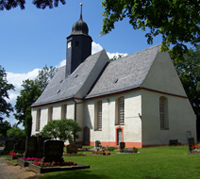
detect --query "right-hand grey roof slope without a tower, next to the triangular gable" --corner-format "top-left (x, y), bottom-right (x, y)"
top-left (86, 45), bottom-right (160, 98)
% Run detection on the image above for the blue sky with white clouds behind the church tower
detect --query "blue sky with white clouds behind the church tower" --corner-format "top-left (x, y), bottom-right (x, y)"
top-left (0, 0), bottom-right (161, 126)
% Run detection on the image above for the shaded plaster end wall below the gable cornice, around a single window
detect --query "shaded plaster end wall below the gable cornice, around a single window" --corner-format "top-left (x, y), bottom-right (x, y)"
top-left (142, 90), bottom-right (196, 145)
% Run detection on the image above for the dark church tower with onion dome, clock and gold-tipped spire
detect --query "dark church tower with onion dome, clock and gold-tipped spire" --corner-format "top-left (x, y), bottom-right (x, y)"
top-left (66, 3), bottom-right (92, 77)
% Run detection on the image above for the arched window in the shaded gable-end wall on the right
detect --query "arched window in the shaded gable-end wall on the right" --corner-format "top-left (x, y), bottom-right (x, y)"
top-left (159, 96), bottom-right (169, 129)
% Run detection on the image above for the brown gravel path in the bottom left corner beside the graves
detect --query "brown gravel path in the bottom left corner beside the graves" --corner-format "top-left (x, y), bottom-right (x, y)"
top-left (0, 157), bottom-right (39, 179)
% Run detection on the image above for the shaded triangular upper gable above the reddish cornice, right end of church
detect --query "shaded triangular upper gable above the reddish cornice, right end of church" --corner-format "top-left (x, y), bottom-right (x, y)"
top-left (141, 52), bottom-right (187, 96)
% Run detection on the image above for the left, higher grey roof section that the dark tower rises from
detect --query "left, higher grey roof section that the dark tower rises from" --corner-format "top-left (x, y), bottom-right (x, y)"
top-left (32, 50), bottom-right (108, 107)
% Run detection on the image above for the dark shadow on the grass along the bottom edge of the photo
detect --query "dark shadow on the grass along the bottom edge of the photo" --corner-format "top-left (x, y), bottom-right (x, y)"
top-left (40, 170), bottom-right (110, 179)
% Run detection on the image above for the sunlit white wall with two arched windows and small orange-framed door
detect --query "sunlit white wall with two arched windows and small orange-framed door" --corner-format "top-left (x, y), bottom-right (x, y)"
top-left (83, 91), bottom-right (142, 147)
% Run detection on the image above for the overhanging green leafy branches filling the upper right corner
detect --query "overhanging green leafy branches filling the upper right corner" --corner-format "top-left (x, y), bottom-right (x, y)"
top-left (101, 0), bottom-right (200, 55)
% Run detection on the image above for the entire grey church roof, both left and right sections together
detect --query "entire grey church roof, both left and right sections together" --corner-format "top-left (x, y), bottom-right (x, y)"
top-left (32, 45), bottom-right (160, 107)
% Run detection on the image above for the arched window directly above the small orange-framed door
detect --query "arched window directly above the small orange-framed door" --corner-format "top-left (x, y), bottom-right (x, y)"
top-left (116, 96), bottom-right (124, 125)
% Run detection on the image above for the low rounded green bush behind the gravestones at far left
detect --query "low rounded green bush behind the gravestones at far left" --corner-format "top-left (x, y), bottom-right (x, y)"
top-left (7, 127), bottom-right (26, 140)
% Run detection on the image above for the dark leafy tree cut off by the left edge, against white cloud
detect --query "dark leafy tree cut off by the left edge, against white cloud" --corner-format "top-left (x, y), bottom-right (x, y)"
top-left (0, 65), bottom-right (14, 125)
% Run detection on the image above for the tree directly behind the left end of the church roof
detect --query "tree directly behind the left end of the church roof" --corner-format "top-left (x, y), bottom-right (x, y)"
top-left (14, 66), bottom-right (56, 136)
